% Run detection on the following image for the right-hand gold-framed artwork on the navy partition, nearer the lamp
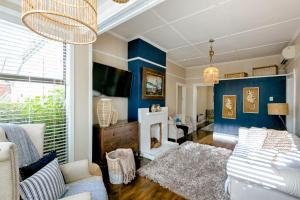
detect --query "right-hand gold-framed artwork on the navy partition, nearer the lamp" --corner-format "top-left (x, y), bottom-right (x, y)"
top-left (243, 87), bottom-right (259, 113)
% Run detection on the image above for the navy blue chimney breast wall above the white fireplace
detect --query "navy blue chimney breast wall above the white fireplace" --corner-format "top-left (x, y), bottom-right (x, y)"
top-left (128, 39), bottom-right (166, 121)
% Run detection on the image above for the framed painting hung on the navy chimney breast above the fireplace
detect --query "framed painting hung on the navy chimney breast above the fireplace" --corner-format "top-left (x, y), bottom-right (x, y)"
top-left (142, 67), bottom-right (166, 100)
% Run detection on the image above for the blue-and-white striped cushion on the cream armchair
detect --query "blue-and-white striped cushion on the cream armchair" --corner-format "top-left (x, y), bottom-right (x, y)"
top-left (20, 159), bottom-right (66, 200)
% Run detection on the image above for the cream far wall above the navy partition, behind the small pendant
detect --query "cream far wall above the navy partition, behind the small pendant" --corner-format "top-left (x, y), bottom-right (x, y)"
top-left (185, 55), bottom-right (281, 116)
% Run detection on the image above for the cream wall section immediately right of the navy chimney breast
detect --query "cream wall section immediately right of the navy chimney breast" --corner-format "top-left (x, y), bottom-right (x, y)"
top-left (166, 61), bottom-right (185, 115)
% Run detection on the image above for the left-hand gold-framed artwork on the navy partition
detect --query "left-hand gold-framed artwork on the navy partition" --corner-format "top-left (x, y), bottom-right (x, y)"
top-left (222, 95), bottom-right (236, 119)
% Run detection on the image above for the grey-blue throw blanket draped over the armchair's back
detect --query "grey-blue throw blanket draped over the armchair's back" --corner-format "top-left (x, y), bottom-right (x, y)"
top-left (0, 124), bottom-right (40, 167)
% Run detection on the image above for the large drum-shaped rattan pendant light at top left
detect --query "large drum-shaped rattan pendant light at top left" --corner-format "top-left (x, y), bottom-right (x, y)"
top-left (22, 0), bottom-right (97, 44)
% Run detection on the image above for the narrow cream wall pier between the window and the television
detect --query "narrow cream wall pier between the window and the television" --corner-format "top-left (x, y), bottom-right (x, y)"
top-left (74, 45), bottom-right (92, 161)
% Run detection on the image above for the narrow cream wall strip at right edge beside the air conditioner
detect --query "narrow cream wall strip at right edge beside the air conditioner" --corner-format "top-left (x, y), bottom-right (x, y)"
top-left (288, 34), bottom-right (300, 136)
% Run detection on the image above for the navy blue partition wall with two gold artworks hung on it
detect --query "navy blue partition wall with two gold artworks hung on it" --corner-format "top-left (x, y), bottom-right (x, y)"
top-left (214, 76), bottom-right (286, 135)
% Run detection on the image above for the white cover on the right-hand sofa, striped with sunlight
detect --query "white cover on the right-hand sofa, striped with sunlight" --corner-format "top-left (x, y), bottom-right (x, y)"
top-left (227, 136), bottom-right (300, 198)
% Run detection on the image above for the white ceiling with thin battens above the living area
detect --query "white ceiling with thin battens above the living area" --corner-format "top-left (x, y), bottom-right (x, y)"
top-left (111, 0), bottom-right (300, 67)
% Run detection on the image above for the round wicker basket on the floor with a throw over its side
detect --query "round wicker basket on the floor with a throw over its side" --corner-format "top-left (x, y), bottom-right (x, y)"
top-left (106, 151), bottom-right (123, 184)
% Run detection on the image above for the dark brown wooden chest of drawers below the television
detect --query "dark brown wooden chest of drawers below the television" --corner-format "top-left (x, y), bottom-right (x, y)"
top-left (93, 122), bottom-right (139, 163)
